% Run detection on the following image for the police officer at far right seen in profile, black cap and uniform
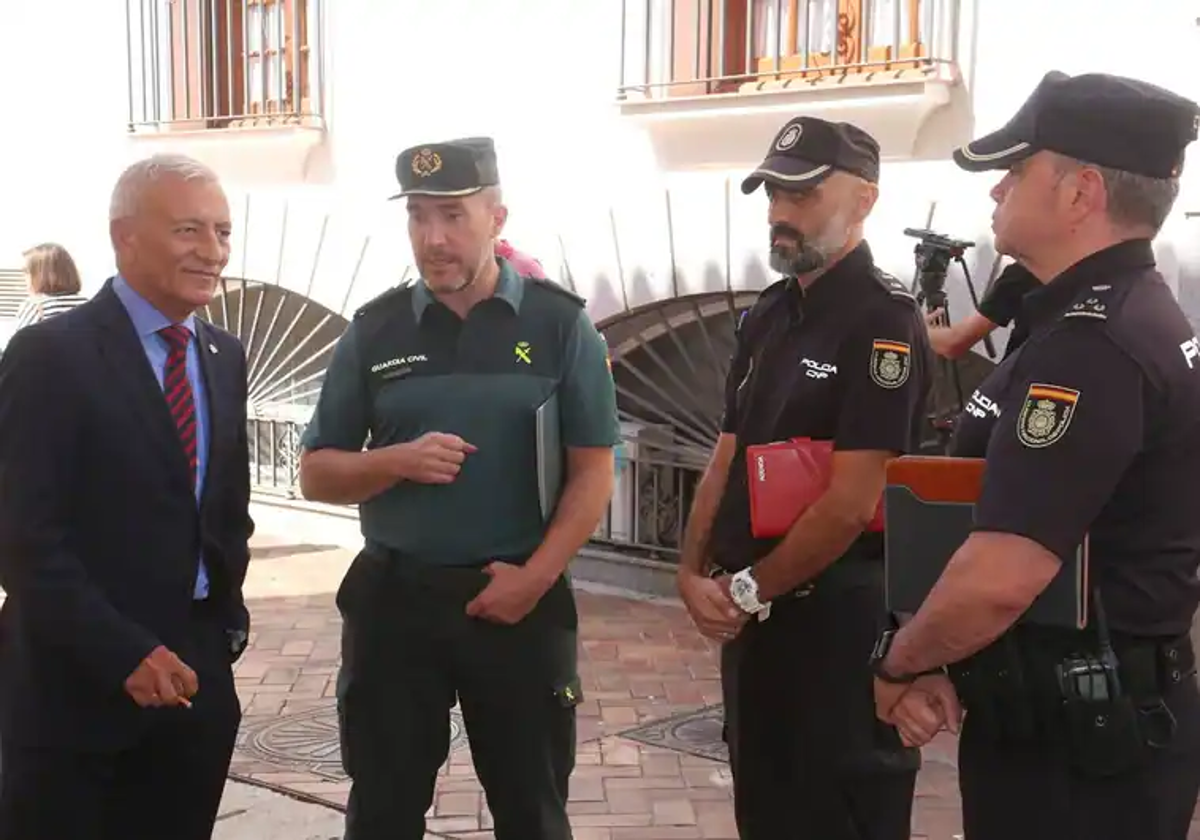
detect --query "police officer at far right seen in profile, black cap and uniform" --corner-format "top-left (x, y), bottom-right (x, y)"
top-left (875, 73), bottom-right (1200, 840)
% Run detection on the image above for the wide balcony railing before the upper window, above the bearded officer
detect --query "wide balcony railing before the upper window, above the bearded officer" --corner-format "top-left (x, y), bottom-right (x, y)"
top-left (618, 0), bottom-right (960, 98)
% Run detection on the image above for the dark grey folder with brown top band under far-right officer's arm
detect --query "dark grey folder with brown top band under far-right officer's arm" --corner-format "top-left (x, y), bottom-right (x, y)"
top-left (883, 455), bottom-right (1088, 628)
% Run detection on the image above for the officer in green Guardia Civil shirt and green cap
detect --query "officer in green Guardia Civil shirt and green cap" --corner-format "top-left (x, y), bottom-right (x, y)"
top-left (300, 138), bottom-right (619, 840)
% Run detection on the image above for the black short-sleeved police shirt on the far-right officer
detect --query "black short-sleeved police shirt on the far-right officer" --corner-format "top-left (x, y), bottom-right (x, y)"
top-left (952, 240), bottom-right (1200, 636)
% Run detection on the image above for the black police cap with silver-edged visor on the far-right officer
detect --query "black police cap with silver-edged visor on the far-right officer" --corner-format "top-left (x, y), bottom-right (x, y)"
top-left (954, 71), bottom-right (1200, 179)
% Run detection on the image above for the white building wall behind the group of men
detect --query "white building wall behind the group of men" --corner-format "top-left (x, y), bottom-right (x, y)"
top-left (0, 0), bottom-right (1200, 319)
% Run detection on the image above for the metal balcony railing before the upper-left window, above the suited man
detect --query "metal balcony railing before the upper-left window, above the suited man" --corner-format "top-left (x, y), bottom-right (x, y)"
top-left (125, 0), bottom-right (323, 131)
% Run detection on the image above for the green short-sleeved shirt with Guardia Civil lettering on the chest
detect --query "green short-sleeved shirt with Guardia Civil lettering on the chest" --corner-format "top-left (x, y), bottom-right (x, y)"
top-left (304, 259), bottom-right (620, 565)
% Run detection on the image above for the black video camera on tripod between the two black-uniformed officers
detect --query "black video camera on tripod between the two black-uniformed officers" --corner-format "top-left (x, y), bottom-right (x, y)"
top-left (904, 228), bottom-right (996, 451)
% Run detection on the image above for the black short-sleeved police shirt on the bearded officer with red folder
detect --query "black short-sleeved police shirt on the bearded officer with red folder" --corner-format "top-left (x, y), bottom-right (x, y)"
top-left (710, 242), bottom-right (932, 571)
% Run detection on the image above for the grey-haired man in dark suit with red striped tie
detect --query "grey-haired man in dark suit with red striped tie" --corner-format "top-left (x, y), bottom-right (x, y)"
top-left (0, 156), bottom-right (253, 840)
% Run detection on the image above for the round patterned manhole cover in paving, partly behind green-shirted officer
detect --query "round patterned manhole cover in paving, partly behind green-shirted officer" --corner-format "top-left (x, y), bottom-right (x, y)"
top-left (238, 704), bottom-right (467, 779)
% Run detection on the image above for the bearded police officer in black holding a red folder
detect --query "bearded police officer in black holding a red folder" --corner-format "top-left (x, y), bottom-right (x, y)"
top-left (679, 116), bottom-right (932, 840)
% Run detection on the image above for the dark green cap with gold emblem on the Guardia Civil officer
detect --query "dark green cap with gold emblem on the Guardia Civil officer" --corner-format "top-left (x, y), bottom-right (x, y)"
top-left (392, 137), bottom-right (500, 199)
